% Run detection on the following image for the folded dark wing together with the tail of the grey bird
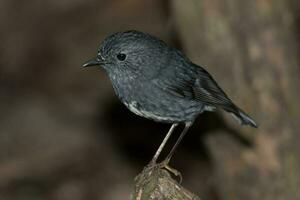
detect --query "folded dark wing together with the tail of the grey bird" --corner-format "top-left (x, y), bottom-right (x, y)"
top-left (154, 62), bottom-right (257, 127)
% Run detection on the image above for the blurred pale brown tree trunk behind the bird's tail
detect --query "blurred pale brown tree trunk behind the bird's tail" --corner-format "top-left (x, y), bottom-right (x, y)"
top-left (172, 0), bottom-right (300, 200)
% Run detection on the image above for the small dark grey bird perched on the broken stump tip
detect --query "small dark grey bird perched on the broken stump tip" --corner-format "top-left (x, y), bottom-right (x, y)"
top-left (83, 31), bottom-right (257, 170)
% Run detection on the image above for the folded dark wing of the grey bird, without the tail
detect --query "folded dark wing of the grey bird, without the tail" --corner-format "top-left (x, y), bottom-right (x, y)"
top-left (154, 65), bottom-right (233, 108)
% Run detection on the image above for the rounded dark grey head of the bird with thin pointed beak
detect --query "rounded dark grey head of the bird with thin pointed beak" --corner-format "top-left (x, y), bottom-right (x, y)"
top-left (83, 31), bottom-right (168, 77)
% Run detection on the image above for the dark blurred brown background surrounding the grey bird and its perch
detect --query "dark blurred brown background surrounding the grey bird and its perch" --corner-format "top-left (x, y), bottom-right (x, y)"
top-left (0, 0), bottom-right (300, 200)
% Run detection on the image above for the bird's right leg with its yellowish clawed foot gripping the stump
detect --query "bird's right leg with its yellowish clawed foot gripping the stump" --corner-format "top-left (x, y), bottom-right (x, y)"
top-left (159, 122), bottom-right (193, 182)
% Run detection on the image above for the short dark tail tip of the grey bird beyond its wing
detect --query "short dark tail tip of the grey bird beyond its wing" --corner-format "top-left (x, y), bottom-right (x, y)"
top-left (224, 105), bottom-right (258, 128)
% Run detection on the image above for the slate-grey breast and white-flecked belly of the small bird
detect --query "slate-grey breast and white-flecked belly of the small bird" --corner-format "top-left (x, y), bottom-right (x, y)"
top-left (106, 71), bottom-right (202, 123)
